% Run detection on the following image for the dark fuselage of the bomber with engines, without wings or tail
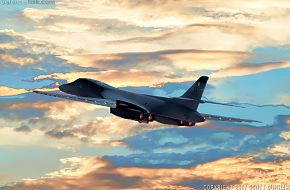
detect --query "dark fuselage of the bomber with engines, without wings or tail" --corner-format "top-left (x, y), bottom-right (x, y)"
top-left (59, 79), bottom-right (205, 126)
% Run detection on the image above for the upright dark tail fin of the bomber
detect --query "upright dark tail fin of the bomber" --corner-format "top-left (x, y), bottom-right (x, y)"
top-left (181, 76), bottom-right (208, 100)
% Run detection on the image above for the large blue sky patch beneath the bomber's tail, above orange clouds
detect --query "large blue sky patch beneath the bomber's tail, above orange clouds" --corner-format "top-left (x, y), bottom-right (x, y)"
top-left (105, 113), bottom-right (289, 168)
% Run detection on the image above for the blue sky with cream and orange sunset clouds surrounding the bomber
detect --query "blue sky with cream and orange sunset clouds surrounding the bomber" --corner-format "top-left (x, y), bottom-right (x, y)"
top-left (0, 0), bottom-right (290, 190)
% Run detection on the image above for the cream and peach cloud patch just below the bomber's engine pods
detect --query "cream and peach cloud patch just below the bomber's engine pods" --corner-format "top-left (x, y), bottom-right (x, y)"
top-left (46, 116), bottom-right (152, 145)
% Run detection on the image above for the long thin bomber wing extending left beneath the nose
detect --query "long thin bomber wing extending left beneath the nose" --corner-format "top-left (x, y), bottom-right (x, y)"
top-left (33, 90), bottom-right (117, 108)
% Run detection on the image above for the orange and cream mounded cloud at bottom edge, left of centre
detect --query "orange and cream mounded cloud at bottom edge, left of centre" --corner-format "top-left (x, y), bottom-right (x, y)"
top-left (1, 158), bottom-right (141, 190)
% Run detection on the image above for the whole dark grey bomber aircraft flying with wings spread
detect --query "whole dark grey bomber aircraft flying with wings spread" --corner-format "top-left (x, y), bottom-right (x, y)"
top-left (33, 76), bottom-right (257, 126)
